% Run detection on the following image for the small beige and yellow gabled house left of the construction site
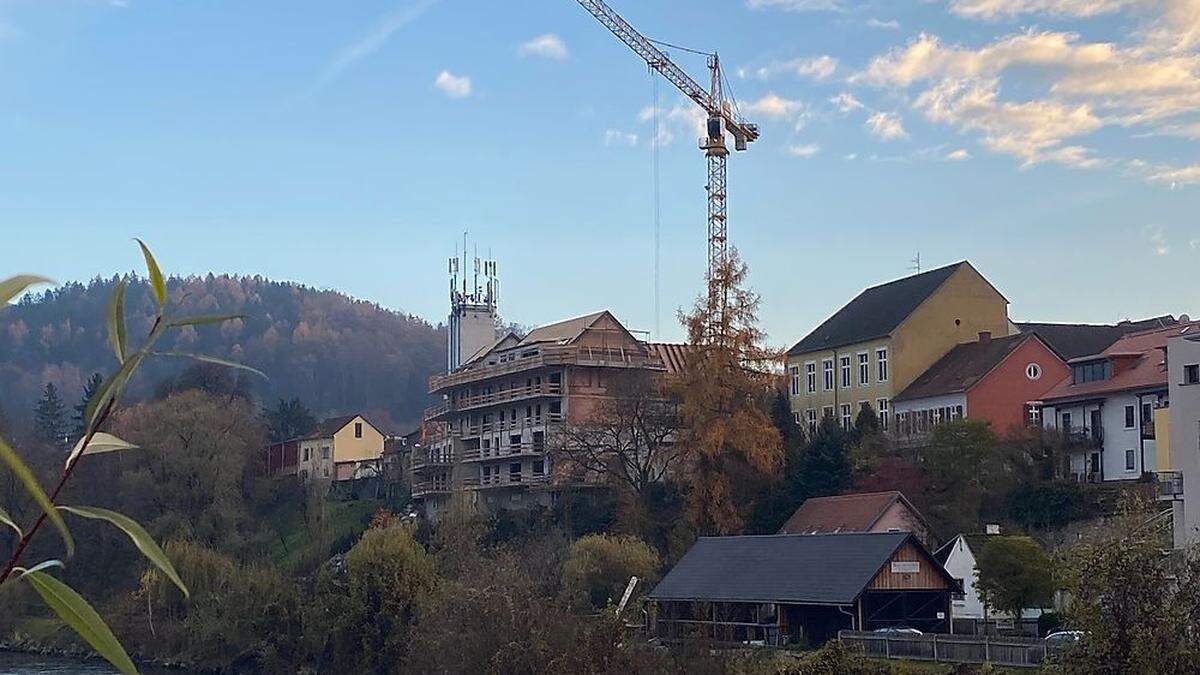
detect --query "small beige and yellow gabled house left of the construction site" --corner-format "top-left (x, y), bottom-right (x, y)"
top-left (296, 414), bottom-right (384, 482)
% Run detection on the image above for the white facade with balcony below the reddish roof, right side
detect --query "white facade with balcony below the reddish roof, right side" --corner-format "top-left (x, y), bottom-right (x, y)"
top-left (1042, 392), bottom-right (1166, 480)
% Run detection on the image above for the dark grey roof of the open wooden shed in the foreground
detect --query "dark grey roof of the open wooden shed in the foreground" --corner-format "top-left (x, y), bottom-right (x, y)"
top-left (649, 532), bottom-right (922, 604)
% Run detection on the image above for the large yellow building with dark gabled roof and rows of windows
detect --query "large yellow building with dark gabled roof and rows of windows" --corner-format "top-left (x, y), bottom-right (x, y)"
top-left (787, 261), bottom-right (1015, 430)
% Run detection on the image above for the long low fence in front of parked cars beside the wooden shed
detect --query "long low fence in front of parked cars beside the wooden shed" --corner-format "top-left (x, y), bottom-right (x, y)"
top-left (838, 631), bottom-right (1046, 667)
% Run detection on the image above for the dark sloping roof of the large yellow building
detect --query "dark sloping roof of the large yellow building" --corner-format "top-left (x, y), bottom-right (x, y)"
top-left (787, 261), bottom-right (970, 356)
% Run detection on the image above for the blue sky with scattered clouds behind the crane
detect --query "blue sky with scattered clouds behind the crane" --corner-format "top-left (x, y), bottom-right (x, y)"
top-left (0, 0), bottom-right (1200, 345)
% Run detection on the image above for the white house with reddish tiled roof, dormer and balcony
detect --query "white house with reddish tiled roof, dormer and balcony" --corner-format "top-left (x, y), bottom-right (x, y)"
top-left (1042, 322), bottom-right (1200, 482)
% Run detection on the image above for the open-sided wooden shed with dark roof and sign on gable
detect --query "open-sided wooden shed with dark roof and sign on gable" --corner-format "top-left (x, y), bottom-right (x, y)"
top-left (647, 532), bottom-right (961, 645)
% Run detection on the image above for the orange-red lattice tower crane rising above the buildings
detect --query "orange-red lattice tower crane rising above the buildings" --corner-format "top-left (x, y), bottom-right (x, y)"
top-left (577, 0), bottom-right (758, 295)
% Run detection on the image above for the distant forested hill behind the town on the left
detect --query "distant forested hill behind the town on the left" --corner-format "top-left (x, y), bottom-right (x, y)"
top-left (0, 274), bottom-right (445, 429)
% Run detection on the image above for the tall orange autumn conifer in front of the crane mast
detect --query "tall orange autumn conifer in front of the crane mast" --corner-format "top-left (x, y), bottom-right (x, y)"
top-left (677, 250), bottom-right (784, 534)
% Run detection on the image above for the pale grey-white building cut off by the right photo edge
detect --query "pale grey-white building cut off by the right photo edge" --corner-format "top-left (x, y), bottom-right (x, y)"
top-left (1166, 336), bottom-right (1200, 548)
